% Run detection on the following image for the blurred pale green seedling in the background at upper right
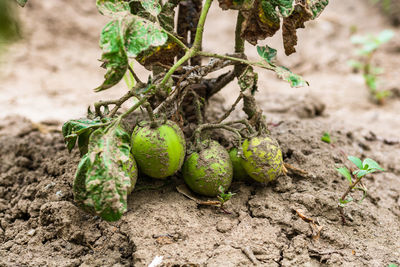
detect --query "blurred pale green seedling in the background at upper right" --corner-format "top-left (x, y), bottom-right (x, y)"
top-left (349, 30), bottom-right (394, 104)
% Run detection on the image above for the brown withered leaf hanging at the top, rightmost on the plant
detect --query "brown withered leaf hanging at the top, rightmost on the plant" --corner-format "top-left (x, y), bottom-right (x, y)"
top-left (282, 0), bottom-right (329, 55)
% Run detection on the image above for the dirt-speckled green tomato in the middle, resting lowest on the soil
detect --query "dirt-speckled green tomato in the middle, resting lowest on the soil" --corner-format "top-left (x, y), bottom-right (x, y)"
top-left (182, 140), bottom-right (233, 197)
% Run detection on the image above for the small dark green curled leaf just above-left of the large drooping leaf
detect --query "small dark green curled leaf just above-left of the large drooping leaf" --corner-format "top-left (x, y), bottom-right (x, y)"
top-left (62, 119), bottom-right (103, 152)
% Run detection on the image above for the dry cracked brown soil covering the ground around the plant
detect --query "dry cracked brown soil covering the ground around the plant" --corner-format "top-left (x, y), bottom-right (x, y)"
top-left (0, 0), bottom-right (400, 266)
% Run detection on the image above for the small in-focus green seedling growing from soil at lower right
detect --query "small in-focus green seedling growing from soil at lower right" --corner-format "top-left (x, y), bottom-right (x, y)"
top-left (336, 156), bottom-right (384, 207)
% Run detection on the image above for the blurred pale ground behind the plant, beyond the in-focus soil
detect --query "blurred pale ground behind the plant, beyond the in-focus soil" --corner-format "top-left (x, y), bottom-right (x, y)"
top-left (0, 0), bottom-right (400, 137)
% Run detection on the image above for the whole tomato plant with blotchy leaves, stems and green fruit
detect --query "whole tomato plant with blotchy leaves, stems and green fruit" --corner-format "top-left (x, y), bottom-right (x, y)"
top-left (18, 0), bottom-right (328, 221)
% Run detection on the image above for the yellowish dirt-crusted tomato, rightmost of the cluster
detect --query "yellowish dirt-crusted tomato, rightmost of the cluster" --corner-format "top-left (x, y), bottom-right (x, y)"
top-left (241, 136), bottom-right (283, 183)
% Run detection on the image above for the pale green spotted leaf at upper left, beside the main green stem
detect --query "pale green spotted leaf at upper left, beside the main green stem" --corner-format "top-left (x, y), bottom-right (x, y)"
top-left (124, 15), bottom-right (168, 57)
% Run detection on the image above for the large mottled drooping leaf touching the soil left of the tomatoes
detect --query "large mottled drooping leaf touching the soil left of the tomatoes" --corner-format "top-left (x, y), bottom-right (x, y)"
top-left (73, 124), bottom-right (137, 221)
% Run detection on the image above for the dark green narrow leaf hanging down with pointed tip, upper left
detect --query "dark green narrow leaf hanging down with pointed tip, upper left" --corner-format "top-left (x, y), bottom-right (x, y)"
top-left (94, 20), bottom-right (128, 92)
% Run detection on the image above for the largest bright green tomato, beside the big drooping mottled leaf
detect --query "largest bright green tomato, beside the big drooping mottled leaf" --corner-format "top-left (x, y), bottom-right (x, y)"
top-left (131, 121), bottom-right (186, 179)
